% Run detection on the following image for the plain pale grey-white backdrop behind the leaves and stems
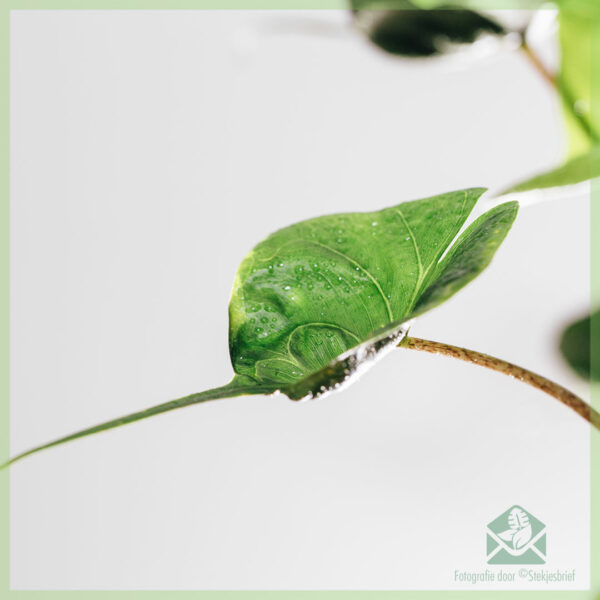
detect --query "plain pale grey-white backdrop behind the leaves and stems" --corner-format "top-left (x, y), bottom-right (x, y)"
top-left (11, 11), bottom-right (589, 589)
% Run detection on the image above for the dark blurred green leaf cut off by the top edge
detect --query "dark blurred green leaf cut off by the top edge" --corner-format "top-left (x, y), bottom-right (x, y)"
top-left (352, 0), bottom-right (505, 57)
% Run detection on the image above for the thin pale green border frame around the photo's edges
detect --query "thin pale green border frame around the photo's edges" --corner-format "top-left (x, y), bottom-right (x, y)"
top-left (0, 0), bottom-right (600, 600)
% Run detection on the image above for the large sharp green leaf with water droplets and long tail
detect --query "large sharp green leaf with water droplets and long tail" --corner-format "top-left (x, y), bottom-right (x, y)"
top-left (1, 188), bottom-right (518, 461)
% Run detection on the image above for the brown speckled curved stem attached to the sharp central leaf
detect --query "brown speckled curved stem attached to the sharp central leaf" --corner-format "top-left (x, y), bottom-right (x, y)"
top-left (398, 336), bottom-right (600, 430)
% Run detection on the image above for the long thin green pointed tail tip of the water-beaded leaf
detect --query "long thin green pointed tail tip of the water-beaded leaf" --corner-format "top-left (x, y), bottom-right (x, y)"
top-left (0, 381), bottom-right (273, 469)
